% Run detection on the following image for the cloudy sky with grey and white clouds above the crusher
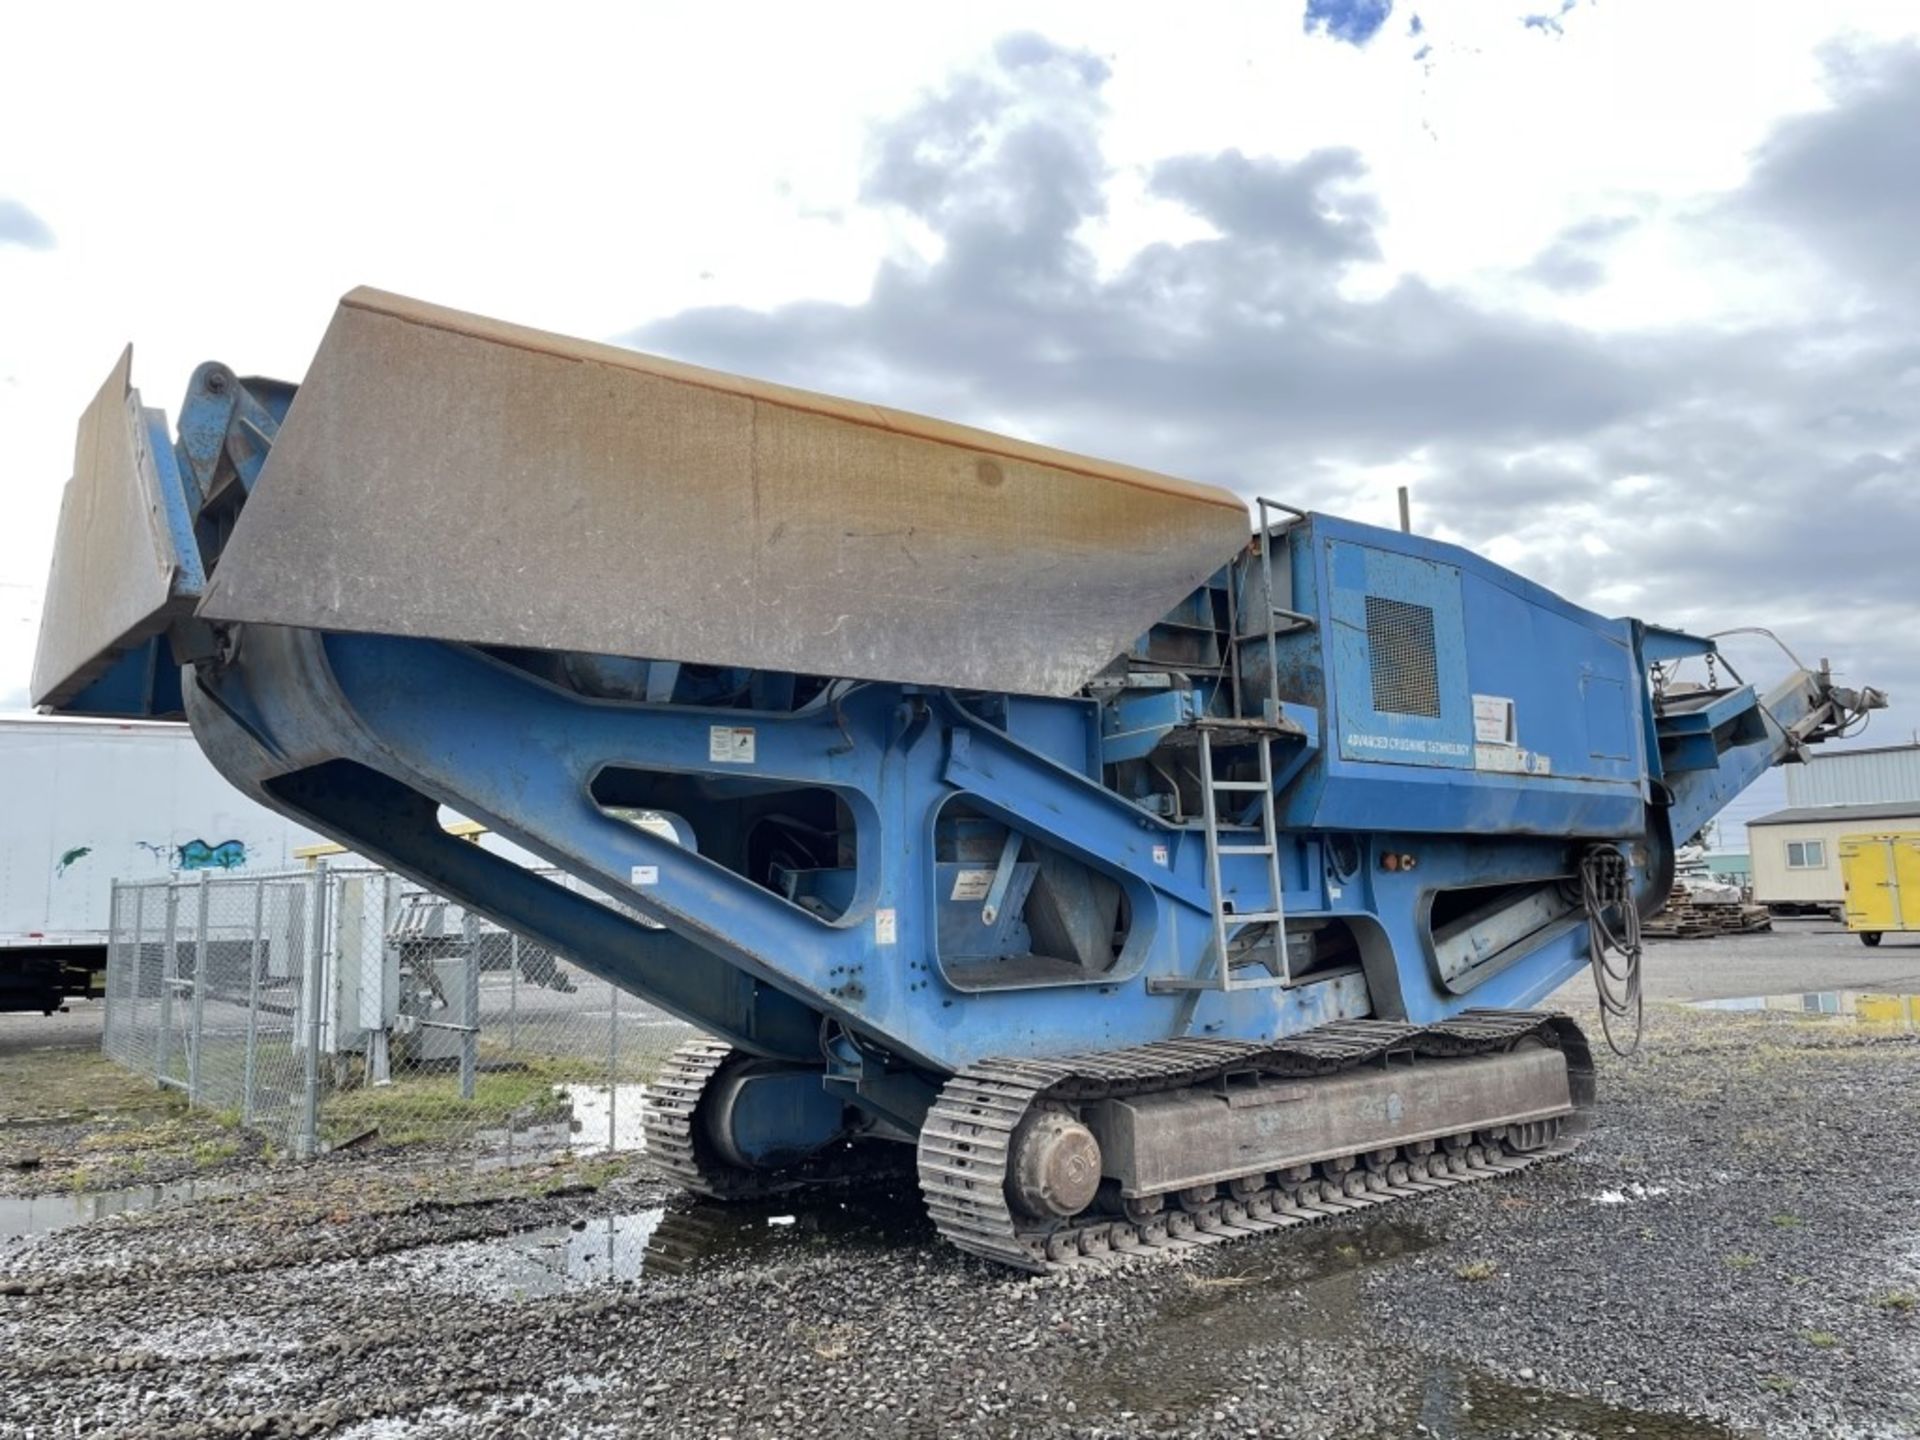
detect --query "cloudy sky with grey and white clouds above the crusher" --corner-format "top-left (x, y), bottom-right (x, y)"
top-left (0, 0), bottom-right (1920, 844)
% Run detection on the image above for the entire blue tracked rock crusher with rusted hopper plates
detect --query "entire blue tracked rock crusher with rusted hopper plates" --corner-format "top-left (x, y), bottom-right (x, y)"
top-left (33, 290), bottom-right (1884, 1269)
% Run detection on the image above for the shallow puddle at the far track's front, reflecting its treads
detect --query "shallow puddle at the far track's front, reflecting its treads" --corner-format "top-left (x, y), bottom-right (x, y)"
top-left (396, 1190), bottom-right (933, 1300)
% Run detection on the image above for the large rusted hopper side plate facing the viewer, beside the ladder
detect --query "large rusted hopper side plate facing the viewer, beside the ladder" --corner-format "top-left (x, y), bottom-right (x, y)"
top-left (200, 290), bottom-right (1248, 695)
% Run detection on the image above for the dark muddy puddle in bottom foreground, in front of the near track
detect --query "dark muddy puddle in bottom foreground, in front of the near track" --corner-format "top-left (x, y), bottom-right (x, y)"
top-left (1068, 1219), bottom-right (1736, 1440)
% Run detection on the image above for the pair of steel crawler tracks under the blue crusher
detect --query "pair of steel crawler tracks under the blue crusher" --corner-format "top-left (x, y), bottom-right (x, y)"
top-left (647, 1012), bottom-right (1594, 1271)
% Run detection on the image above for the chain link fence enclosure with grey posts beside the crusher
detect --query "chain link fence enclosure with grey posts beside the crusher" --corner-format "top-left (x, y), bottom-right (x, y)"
top-left (104, 864), bottom-right (691, 1164)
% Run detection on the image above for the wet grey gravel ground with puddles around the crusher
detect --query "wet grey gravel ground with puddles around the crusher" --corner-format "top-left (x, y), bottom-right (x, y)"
top-left (0, 927), bottom-right (1920, 1440)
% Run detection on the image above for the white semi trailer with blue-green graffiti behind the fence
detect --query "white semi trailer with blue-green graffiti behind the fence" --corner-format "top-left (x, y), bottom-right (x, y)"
top-left (0, 716), bottom-right (321, 1012)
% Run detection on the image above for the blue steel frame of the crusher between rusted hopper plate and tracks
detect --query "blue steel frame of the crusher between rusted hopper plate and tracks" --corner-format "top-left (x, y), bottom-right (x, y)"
top-left (52, 365), bottom-right (1814, 1152)
